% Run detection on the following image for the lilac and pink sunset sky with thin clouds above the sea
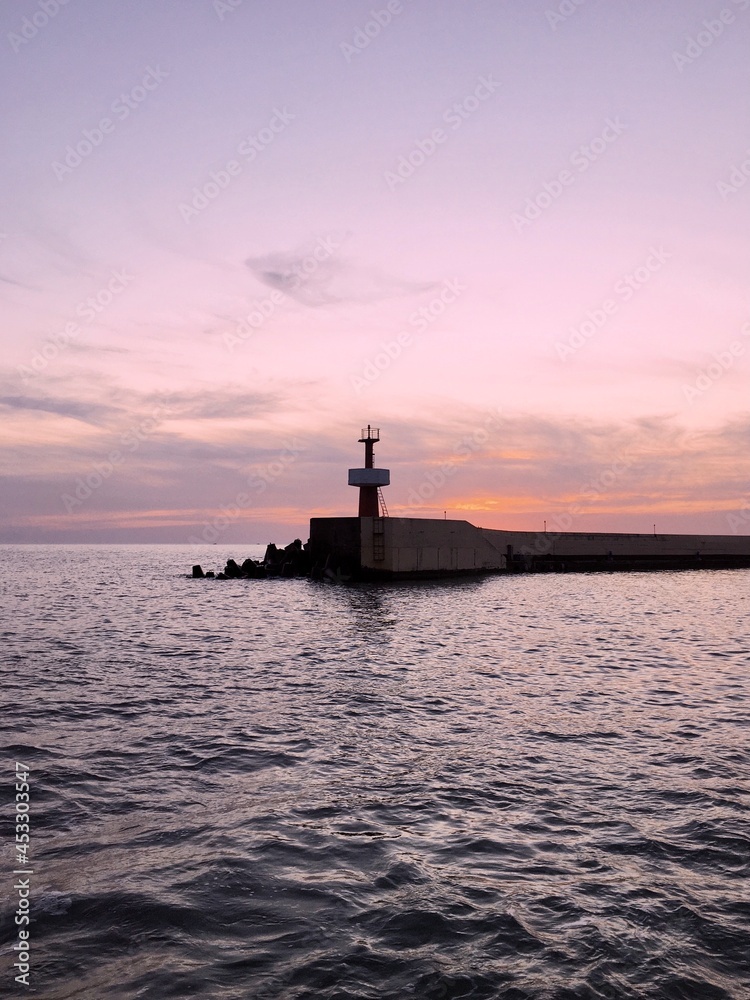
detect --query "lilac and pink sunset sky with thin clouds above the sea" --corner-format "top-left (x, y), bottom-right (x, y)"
top-left (0, 0), bottom-right (750, 544)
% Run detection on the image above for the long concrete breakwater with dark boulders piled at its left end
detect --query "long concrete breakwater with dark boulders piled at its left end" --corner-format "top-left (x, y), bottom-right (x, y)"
top-left (193, 517), bottom-right (750, 580)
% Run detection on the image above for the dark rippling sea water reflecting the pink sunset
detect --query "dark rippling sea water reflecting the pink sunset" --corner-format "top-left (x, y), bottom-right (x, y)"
top-left (0, 546), bottom-right (750, 1000)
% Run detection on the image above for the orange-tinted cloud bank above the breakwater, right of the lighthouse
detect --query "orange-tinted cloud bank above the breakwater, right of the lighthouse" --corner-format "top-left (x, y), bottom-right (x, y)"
top-left (376, 408), bottom-right (750, 526)
